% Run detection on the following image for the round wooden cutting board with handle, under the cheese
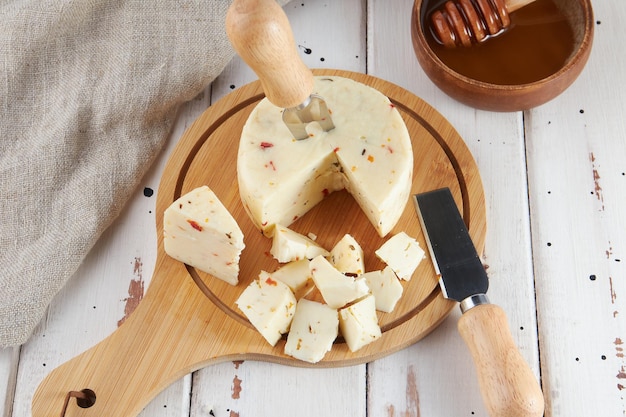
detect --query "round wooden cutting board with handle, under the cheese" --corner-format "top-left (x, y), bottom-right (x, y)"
top-left (32, 70), bottom-right (486, 417)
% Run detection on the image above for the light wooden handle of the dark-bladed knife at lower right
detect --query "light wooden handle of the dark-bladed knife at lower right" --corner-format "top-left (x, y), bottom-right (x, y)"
top-left (458, 304), bottom-right (544, 417)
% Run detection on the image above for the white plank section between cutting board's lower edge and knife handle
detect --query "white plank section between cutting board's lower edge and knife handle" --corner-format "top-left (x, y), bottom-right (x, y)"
top-left (367, 310), bottom-right (487, 417)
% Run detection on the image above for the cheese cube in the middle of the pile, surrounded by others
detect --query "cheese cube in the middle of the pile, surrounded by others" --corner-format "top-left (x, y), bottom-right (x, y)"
top-left (309, 255), bottom-right (369, 308)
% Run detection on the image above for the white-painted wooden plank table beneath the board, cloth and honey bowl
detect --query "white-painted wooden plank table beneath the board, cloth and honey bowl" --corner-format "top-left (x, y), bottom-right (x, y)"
top-left (0, 0), bottom-right (626, 417)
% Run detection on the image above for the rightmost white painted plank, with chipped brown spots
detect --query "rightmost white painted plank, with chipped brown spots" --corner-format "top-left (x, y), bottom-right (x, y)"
top-left (528, 2), bottom-right (626, 417)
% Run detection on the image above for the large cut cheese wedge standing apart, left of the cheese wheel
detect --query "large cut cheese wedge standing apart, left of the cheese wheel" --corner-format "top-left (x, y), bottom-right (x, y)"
top-left (163, 186), bottom-right (245, 285)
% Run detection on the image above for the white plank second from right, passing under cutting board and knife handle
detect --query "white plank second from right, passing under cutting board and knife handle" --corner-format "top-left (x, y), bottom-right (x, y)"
top-left (368, 0), bottom-right (539, 416)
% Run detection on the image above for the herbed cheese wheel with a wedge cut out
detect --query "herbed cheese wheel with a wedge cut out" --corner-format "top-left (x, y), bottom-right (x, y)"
top-left (237, 76), bottom-right (413, 237)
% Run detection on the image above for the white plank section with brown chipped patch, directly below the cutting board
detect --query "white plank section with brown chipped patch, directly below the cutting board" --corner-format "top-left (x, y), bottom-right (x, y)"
top-left (191, 361), bottom-right (366, 417)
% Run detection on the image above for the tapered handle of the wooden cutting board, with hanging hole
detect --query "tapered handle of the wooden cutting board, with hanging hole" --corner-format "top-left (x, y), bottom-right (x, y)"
top-left (32, 257), bottom-right (263, 417)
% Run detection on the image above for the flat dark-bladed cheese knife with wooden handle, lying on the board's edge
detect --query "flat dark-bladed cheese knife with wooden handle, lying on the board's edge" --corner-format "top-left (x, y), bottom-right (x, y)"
top-left (414, 188), bottom-right (544, 417)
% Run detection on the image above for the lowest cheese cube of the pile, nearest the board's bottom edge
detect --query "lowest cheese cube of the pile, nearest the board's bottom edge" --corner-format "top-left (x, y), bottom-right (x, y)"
top-left (285, 298), bottom-right (339, 363)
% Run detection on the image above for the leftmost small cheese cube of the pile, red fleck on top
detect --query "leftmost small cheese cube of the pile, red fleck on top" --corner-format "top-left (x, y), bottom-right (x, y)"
top-left (236, 277), bottom-right (296, 346)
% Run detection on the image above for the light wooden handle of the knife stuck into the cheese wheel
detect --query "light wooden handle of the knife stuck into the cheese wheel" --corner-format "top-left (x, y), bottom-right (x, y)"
top-left (226, 0), bottom-right (313, 108)
